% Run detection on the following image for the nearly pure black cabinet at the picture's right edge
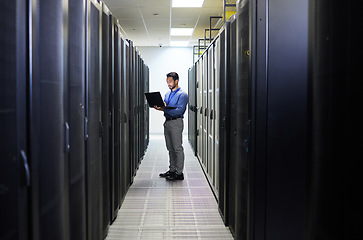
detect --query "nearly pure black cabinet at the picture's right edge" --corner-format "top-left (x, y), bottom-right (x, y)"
top-left (305, 0), bottom-right (363, 240)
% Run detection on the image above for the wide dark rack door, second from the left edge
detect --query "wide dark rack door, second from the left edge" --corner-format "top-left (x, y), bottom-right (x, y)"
top-left (29, 0), bottom-right (69, 239)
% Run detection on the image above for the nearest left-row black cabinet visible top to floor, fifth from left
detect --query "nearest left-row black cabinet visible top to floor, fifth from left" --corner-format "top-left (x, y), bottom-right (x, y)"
top-left (101, 4), bottom-right (113, 237)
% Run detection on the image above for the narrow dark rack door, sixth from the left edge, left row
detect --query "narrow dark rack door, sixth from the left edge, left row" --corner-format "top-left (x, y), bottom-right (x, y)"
top-left (111, 18), bottom-right (123, 221)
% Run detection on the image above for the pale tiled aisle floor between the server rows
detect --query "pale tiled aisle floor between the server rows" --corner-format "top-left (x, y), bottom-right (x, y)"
top-left (106, 135), bottom-right (233, 240)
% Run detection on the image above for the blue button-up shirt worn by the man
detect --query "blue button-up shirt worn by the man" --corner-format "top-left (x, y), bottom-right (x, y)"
top-left (164, 88), bottom-right (189, 118)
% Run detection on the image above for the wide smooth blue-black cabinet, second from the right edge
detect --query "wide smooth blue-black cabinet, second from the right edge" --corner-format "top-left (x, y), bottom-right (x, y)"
top-left (250, 0), bottom-right (308, 240)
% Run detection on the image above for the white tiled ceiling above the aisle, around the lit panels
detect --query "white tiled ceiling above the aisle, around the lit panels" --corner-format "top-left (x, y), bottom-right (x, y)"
top-left (103, 0), bottom-right (236, 47)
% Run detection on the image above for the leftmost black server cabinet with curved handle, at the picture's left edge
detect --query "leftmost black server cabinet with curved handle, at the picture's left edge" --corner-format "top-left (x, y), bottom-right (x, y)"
top-left (0, 0), bottom-right (30, 240)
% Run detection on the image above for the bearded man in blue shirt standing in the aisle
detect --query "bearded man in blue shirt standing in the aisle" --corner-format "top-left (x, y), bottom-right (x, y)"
top-left (154, 72), bottom-right (188, 180)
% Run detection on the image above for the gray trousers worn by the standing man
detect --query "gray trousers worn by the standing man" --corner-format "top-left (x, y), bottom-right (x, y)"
top-left (164, 118), bottom-right (184, 174)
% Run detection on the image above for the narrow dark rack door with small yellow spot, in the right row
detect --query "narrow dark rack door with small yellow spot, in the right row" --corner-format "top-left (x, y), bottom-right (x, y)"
top-left (235, 0), bottom-right (251, 239)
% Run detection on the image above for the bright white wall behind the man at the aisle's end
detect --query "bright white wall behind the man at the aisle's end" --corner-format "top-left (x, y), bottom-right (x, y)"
top-left (137, 47), bottom-right (193, 134)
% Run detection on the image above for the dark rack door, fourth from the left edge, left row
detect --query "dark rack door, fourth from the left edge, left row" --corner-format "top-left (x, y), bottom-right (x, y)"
top-left (86, 0), bottom-right (103, 239)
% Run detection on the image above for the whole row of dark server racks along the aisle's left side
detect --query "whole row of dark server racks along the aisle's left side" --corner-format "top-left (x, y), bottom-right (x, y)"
top-left (0, 0), bottom-right (149, 239)
